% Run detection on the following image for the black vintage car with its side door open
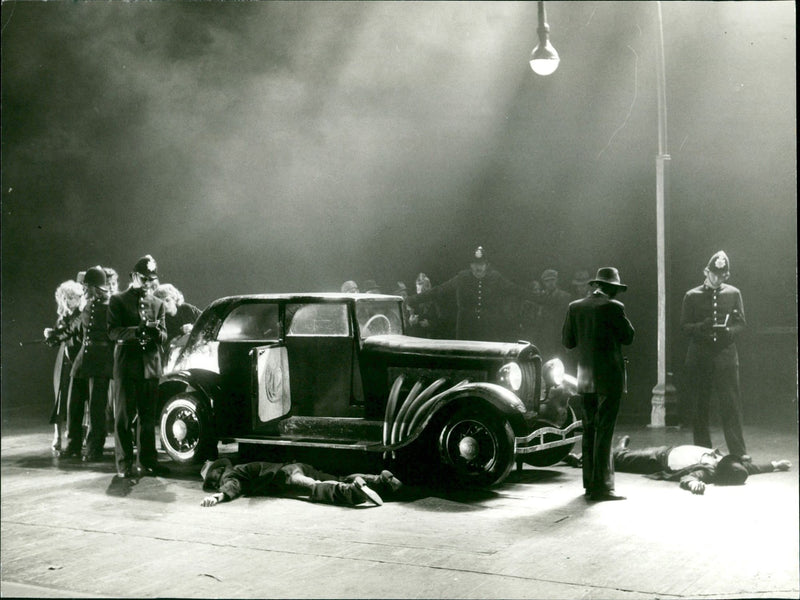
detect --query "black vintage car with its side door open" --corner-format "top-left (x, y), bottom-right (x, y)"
top-left (159, 293), bottom-right (581, 486)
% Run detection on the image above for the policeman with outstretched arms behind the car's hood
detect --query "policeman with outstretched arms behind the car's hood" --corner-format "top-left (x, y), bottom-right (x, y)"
top-left (408, 246), bottom-right (535, 341)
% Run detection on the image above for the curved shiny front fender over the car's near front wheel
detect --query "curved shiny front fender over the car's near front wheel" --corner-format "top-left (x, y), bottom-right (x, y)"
top-left (388, 380), bottom-right (525, 448)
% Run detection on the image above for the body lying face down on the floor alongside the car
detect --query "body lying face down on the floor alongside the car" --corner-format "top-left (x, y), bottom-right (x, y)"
top-left (200, 458), bottom-right (402, 506)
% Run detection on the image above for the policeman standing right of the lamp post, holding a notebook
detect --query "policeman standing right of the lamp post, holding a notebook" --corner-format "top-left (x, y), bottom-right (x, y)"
top-left (681, 250), bottom-right (747, 456)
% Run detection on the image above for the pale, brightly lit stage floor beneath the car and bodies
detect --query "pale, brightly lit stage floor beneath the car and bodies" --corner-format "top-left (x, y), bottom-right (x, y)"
top-left (0, 420), bottom-right (800, 599)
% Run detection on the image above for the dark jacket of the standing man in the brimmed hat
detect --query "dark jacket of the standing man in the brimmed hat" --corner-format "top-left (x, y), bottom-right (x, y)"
top-left (561, 290), bottom-right (634, 396)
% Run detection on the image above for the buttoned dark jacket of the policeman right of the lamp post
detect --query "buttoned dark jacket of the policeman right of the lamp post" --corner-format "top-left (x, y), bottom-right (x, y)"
top-left (681, 283), bottom-right (746, 365)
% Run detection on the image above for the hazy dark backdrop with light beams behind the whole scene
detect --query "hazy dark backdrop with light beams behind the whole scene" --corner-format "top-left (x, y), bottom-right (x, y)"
top-left (2, 1), bottom-right (797, 422)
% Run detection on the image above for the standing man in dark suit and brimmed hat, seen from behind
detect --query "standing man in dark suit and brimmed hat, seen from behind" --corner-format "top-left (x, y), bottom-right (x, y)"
top-left (561, 267), bottom-right (634, 502)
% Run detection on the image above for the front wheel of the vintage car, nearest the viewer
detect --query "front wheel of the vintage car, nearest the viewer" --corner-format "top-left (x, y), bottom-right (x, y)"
top-left (438, 407), bottom-right (514, 487)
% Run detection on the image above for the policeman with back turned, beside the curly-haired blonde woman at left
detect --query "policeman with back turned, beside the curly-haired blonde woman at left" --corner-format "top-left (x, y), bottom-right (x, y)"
top-left (62, 265), bottom-right (114, 461)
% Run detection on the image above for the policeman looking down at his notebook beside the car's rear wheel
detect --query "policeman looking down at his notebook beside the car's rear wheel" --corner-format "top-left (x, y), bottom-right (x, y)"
top-left (108, 254), bottom-right (167, 477)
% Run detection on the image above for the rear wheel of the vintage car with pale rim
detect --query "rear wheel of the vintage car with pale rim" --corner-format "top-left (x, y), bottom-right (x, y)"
top-left (159, 392), bottom-right (217, 463)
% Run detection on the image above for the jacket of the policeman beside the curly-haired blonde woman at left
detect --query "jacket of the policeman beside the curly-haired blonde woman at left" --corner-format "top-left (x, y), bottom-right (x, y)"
top-left (71, 298), bottom-right (114, 379)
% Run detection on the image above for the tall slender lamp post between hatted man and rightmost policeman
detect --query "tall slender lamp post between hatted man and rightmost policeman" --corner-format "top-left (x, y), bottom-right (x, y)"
top-left (650, 2), bottom-right (675, 427)
